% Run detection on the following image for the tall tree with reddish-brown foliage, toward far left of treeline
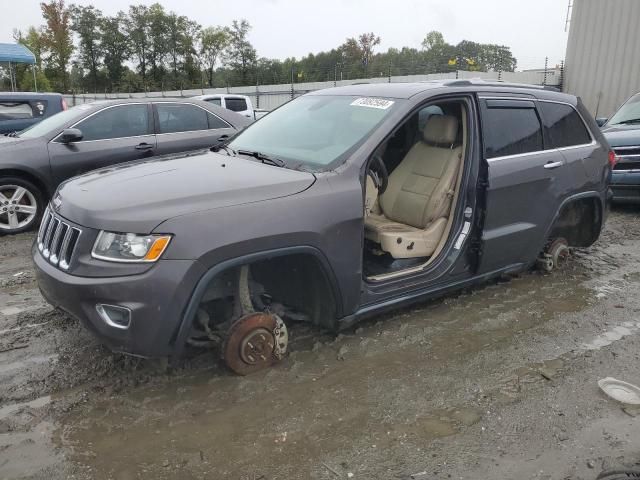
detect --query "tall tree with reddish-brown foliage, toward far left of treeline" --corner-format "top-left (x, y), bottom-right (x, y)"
top-left (40, 0), bottom-right (73, 92)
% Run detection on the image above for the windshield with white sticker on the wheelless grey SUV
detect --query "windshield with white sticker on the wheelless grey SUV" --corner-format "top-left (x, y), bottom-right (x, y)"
top-left (230, 95), bottom-right (398, 170)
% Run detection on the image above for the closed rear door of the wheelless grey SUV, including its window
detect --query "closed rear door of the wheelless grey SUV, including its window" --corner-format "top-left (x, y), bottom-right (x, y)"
top-left (479, 99), bottom-right (567, 273)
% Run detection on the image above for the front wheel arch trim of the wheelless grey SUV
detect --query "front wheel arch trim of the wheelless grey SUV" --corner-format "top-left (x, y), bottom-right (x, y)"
top-left (172, 246), bottom-right (342, 359)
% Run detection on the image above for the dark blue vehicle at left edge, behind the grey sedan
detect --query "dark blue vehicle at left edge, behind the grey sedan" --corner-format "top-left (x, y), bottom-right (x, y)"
top-left (0, 92), bottom-right (67, 134)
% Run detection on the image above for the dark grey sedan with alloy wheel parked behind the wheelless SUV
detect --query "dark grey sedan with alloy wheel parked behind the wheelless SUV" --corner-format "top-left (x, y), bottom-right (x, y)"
top-left (0, 99), bottom-right (250, 234)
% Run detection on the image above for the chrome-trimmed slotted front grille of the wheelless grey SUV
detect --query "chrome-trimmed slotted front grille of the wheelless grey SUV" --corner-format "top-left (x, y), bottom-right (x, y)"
top-left (37, 208), bottom-right (82, 270)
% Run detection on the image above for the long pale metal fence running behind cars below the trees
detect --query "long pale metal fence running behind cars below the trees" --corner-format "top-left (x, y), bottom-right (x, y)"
top-left (64, 68), bottom-right (564, 110)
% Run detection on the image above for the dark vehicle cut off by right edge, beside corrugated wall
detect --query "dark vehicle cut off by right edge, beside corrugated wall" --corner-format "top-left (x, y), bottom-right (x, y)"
top-left (598, 93), bottom-right (640, 203)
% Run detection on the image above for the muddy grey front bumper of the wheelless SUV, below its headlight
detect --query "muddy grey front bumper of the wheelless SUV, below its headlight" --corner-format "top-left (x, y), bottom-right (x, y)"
top-left (32, 245), bottom-right (204, 357)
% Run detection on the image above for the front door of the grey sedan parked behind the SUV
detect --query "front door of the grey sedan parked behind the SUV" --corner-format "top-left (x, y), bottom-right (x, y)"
top-left (48, 104), bottom-right (156, 183)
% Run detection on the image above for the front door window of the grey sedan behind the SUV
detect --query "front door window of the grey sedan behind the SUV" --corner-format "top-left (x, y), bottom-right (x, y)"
top-left (76, 104), bottom-right (149, 141)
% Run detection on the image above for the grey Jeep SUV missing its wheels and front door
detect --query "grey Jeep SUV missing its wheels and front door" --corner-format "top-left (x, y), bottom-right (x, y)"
top-left (33, 81), bottom-right (615, 374)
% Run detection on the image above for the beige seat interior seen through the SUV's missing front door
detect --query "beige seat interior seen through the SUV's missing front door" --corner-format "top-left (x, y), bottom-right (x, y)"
top-left (363, 101), bottom-right (467, 280)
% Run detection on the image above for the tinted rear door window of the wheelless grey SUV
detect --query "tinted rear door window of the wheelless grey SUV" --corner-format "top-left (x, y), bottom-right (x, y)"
top-left (482, 100), bottom-right (543, 158)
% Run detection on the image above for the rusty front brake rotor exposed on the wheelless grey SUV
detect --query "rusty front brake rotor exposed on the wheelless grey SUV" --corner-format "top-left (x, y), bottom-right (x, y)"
top-left (222, 312), bottom-right (288, 375)
